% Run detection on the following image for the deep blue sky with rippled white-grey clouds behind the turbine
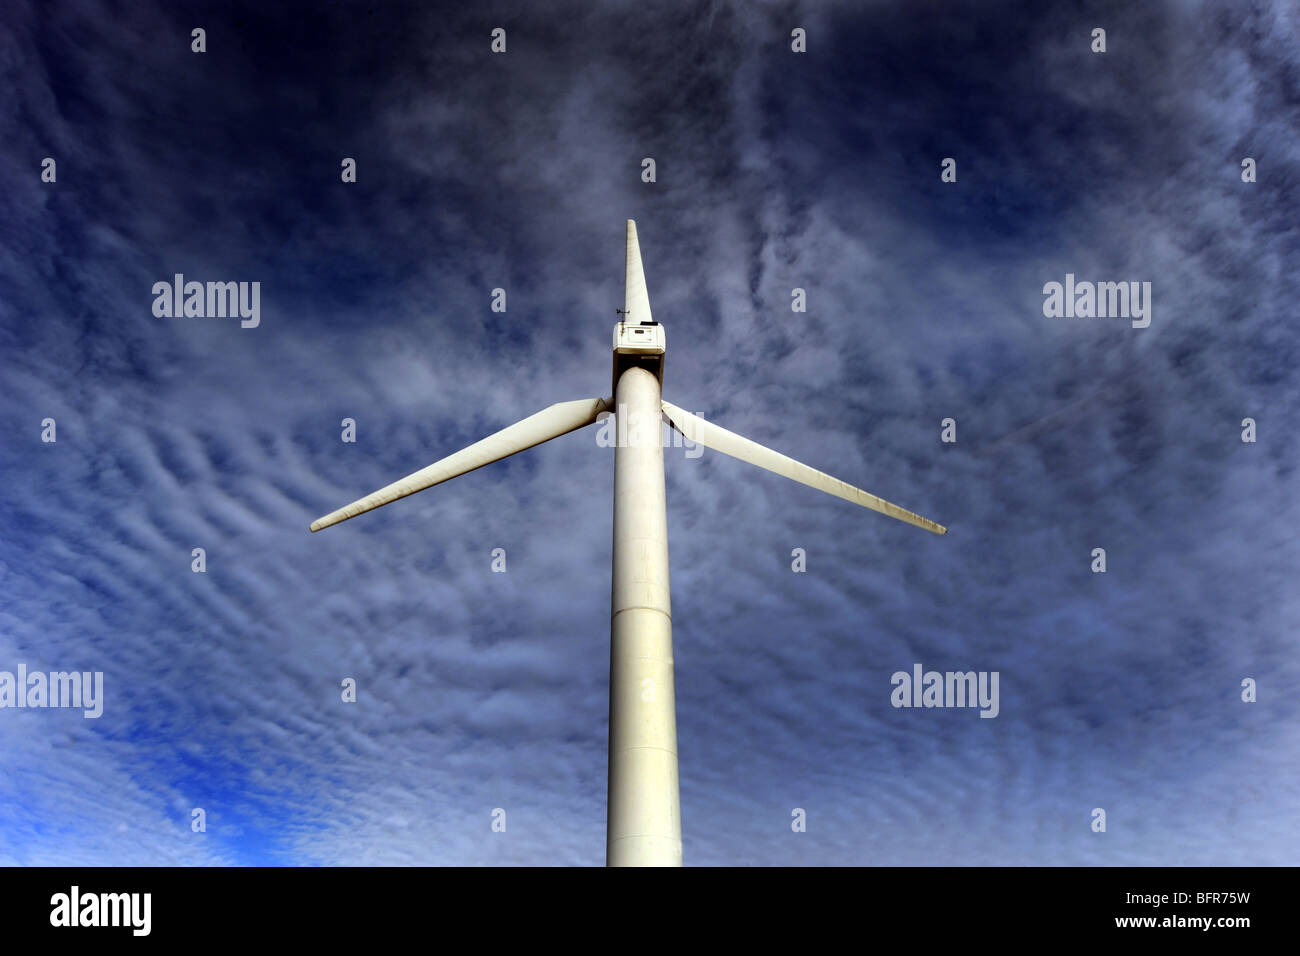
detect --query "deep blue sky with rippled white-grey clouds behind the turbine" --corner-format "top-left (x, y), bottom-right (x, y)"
top-left (0, 3), bottom-right (1300, 865)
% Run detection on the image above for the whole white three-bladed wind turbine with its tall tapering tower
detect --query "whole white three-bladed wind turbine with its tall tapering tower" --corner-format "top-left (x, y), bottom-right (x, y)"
top-left (312, 219), bottom-right (948, 866)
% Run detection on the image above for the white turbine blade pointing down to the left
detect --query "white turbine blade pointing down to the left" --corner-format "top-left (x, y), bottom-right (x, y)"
top-left (312, 398), bottom-right (614, 531)
